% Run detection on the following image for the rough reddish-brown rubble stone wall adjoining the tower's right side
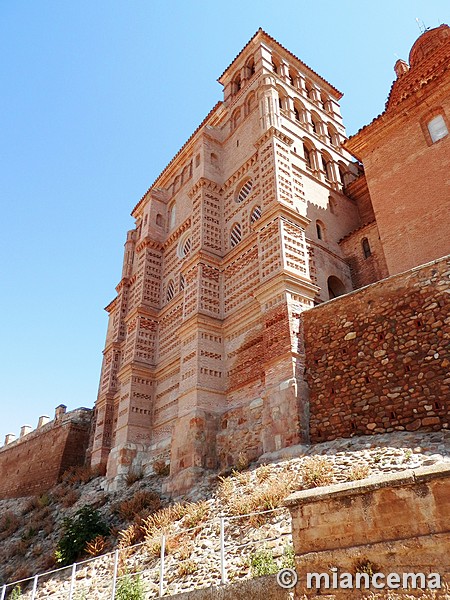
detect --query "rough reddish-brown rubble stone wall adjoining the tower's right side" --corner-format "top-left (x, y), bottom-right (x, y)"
top-left (302, 257), bottom-right (450, 442)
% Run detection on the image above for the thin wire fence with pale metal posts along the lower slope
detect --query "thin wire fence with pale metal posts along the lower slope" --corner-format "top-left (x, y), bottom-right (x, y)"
top-left (0, 508), bottom-right (292, 600)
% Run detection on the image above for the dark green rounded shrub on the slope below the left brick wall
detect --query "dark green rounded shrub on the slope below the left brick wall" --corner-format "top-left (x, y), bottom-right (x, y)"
top-left (55, 506), bottom-right (109, 566)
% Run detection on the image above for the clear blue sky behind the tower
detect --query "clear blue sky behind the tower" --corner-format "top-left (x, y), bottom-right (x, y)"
top-left (0, 0), bottom-right (450, 444)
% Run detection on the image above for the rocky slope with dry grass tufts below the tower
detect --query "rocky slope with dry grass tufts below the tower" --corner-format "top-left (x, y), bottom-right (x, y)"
top-left (0, 431), bottom-right (450, 600)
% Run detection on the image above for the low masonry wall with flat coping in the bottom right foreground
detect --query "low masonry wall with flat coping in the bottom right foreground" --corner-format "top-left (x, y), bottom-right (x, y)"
top-left (286, 464), bottom-right (450, 600)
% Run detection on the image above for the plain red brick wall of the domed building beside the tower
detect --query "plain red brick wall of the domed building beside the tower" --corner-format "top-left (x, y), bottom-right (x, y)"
top-left (352, 86), bottom-right (450, 275)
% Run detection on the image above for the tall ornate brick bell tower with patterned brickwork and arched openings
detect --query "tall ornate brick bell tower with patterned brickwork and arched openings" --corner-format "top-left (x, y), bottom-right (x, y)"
top-left (92, 30), bottom-right (359, 492)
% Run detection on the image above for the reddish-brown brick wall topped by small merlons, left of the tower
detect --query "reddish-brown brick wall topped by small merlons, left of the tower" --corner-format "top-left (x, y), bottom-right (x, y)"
top-left (0, 409), bottom-right (92, 499)
